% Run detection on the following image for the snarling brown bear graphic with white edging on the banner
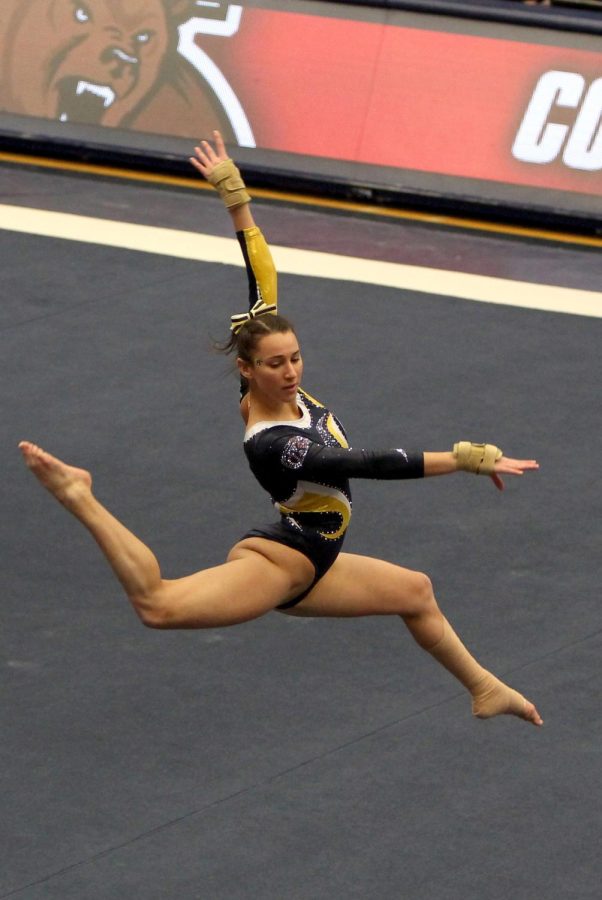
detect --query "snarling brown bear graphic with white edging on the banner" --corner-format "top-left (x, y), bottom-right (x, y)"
top-left (0, 0), bottom-right (254, 146)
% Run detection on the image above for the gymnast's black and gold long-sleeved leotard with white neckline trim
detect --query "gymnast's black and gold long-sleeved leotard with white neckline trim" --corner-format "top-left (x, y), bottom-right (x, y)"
top-left (237, 227), bottom-right (424, 609)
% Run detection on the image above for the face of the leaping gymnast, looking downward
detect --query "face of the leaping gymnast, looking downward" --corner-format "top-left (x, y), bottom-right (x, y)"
top-left (239, 331), bottom-right (303, 403)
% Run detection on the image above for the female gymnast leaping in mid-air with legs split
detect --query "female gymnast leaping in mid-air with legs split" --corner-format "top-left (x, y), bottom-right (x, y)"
top-left (19, 132), bottom-right (542, 725)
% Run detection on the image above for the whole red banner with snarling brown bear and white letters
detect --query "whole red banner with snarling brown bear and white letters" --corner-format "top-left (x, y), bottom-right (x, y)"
top-left (0, 0), bottom-right (602, 202)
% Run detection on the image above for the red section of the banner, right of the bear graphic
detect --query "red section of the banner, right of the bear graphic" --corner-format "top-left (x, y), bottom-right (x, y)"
top-left (197, 9), bottom-right (602, 194)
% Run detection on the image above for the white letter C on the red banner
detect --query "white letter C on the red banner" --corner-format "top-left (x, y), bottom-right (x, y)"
top-left (512, 70), bottom-right (585, 164)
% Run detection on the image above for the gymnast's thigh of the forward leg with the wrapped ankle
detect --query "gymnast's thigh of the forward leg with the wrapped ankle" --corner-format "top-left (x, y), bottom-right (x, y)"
top-left (282, 553), bottom-right (432, 618)
